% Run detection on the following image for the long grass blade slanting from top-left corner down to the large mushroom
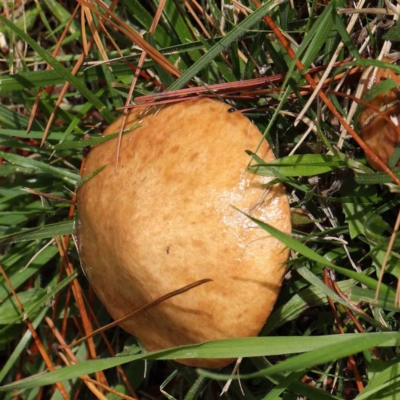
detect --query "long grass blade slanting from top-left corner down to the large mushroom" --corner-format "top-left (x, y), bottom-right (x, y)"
top-left (0, 15), bottom-right (114, 122)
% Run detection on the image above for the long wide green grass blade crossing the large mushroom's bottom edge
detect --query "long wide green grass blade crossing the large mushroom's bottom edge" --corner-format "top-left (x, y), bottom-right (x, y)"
top-left (0, 332), bottom-right (400, 391)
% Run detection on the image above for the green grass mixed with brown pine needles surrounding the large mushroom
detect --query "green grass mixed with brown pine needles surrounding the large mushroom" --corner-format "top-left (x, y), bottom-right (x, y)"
top-left (0, 0), bottom-right (400, 400)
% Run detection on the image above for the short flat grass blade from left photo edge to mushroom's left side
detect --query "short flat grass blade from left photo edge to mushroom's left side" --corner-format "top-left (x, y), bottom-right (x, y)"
top-left (0, 221), bottom-right (76, 244)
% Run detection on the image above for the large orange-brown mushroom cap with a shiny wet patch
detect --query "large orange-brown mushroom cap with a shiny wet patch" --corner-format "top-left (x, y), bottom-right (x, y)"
top-left (78, 99), bottom-right (291, 368)
